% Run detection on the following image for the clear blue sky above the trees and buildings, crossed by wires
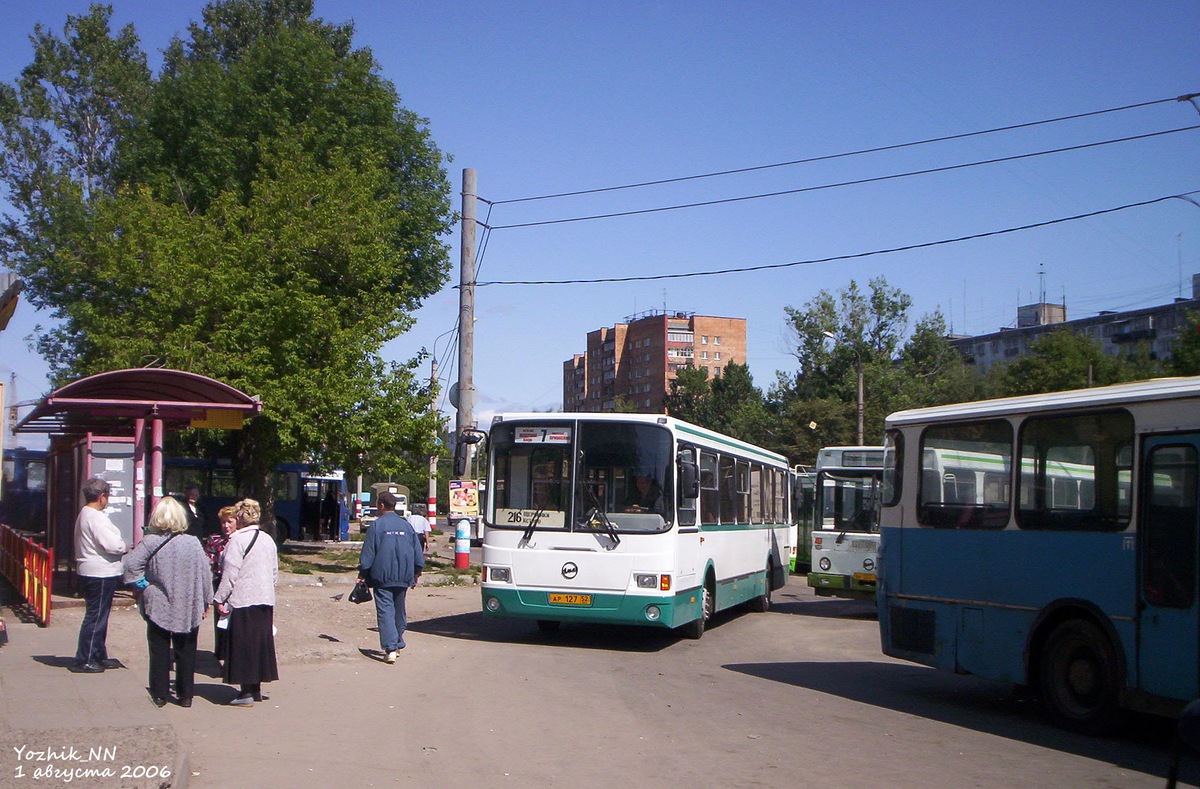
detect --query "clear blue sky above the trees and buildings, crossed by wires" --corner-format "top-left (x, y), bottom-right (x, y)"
top-left (0, 0), bottom-right (1200, 446)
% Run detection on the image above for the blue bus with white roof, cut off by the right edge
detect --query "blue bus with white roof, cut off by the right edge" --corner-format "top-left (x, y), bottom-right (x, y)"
top-left (878, 378), bottom-right (1200, 733)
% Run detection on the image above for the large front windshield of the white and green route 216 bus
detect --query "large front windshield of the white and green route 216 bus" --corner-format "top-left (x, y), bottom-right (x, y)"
top-left (488, 421), bottom-right (674, 532)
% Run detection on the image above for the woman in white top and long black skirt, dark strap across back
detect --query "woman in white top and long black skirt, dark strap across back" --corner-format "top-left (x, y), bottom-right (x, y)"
top-left (215, 499), bottom-right (280, 706)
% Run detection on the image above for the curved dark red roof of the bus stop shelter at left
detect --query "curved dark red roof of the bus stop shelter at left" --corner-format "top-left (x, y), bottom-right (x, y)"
top-left (16, 367), bottom-right (263, 434)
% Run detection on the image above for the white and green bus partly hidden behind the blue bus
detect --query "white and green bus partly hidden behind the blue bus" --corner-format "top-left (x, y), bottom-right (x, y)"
top-left (808, 446), bottom-right (883, 600)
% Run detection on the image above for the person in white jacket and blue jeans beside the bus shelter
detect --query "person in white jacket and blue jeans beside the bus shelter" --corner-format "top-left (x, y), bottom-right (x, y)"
top-left (71, 477), bottom-right (128, 674)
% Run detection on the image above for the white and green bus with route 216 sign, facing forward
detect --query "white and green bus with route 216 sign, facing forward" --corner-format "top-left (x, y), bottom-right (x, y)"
top-left (482, 414), bottom-right (791, 638)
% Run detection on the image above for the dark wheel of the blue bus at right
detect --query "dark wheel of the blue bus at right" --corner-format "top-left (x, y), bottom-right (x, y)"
top-left (1038, 619), bottom-right (1121, 734)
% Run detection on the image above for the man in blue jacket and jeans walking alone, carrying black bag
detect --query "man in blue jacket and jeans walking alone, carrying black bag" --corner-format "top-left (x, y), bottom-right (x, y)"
top-left (359, 492), bottom-right (425, 663)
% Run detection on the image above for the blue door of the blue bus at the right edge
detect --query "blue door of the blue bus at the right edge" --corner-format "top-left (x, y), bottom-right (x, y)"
top-left (1138, 434), bottom-right (1200, 699)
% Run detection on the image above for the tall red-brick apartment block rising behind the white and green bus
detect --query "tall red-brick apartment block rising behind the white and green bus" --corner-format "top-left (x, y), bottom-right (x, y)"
top-left (563, 309), bottom-right (746, 414)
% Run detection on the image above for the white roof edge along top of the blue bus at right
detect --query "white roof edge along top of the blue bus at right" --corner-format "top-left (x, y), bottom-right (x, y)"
top-left (886, 377), bottom-right (1200, 427)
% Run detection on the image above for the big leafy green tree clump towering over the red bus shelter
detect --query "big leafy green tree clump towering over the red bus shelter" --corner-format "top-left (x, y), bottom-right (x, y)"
top-left (0, 0), bottom-right (451, 515)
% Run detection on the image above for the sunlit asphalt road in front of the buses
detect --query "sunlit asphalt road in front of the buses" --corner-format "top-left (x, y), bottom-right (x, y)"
top-left (131, 577), bottom-right (1200, 789)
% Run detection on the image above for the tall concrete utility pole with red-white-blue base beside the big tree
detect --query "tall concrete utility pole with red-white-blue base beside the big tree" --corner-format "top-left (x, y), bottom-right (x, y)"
top-left (454, 168), bottom-right (475, 570)
